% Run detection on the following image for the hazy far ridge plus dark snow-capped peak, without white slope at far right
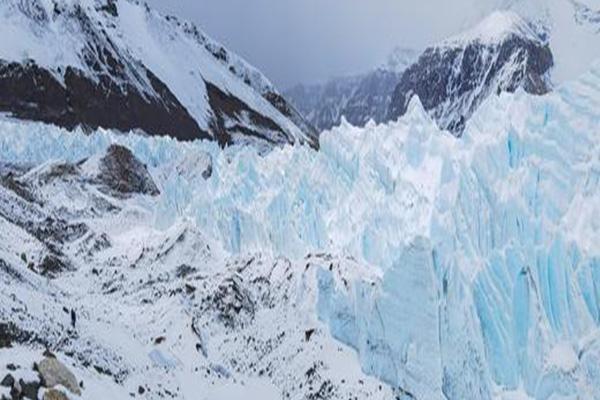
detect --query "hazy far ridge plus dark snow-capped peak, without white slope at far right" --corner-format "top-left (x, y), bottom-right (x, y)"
top-left (285, 11), bottom-right (554, 136)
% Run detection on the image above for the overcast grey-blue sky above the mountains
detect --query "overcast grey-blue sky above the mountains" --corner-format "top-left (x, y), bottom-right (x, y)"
top-left (147, 0), bottom-right (492, 89)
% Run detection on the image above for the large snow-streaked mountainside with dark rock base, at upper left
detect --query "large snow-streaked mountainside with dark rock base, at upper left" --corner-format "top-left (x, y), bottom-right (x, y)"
top-left (0, 0), bottom-right (318, 146)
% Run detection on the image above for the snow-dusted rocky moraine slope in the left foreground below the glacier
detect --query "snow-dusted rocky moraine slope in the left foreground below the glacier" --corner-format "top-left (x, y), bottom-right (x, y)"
top-left (0, 144), bottom-right (396, 400)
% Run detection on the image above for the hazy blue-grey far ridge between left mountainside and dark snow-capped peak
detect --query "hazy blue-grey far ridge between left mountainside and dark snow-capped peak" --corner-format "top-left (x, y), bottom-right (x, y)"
top-left (284, 48), bottom-right (418, 130)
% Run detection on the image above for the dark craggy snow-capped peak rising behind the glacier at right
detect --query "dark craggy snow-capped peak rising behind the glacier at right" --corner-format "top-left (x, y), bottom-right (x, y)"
top-left (389, 11), bottom-right (554, 136)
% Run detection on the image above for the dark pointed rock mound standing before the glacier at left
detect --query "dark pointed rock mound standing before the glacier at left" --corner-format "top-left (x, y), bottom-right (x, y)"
top-left (98, 145), bottom-right (160, 196)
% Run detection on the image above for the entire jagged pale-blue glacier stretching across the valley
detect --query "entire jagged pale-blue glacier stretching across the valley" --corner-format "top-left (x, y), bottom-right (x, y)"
top-left (0, 60), bottom-right (600, 399)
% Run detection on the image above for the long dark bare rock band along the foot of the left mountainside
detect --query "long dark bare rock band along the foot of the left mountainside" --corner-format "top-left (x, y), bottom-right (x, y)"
top-left (0, 60), bottom-right (209, 140)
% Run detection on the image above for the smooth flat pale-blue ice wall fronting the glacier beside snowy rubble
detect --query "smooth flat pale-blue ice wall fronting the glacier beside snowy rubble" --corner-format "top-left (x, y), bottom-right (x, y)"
top-left (319, 238), bottom-right (442, 399)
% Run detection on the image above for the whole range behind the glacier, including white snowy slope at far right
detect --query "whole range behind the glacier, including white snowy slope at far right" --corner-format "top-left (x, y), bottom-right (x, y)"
top-left (285, 0), bottom-right (600, 136)
